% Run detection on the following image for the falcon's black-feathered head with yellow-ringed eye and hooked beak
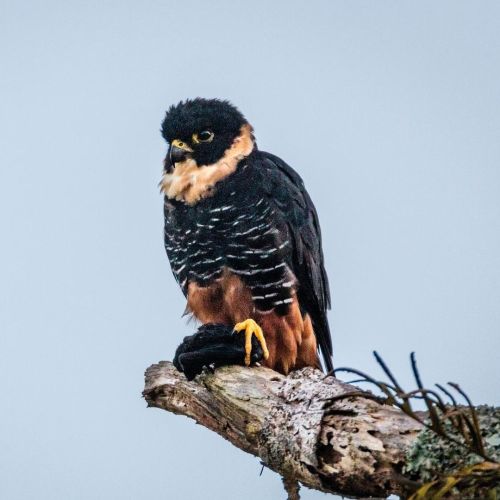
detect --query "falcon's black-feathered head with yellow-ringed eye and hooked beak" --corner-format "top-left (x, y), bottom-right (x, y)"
top-left (161, 97), bottom-right (253, 172)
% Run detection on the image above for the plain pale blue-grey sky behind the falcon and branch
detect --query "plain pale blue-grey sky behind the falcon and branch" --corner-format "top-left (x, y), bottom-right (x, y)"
top-left (0, 0), bottom-right (500, 500)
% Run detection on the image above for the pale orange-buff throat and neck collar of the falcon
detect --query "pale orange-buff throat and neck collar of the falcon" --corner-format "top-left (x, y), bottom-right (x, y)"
top-left (160, 124), bottom-right (254, 205)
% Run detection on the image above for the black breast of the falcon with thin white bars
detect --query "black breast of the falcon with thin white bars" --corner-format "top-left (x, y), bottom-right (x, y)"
top-left (165, 166), bottom-right (296, 314)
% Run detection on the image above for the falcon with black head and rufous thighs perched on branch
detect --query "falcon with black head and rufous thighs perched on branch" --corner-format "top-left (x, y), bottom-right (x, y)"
top-left (160, 98), bottom-right (333, 374)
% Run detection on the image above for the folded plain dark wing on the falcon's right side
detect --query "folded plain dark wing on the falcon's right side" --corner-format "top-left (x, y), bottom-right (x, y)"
top-left (256, 151), bottom-right (333, 371)
